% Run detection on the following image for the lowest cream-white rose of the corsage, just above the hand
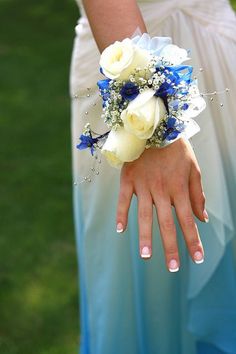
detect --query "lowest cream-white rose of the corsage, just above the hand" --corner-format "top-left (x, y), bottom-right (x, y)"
top-left (102, 127), bottom-right (146, 168)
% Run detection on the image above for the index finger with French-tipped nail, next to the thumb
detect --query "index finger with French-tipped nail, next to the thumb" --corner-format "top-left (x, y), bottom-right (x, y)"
top-left (174, 191), bottom-right (204, 263)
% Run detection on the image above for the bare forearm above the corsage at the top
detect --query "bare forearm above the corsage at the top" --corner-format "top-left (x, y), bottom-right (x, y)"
top-left (83, 0), bottom-right (147, 52)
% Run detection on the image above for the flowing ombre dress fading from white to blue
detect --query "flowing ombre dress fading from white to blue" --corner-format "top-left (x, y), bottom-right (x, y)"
top-left (70, 0), bottom-right (236, 354)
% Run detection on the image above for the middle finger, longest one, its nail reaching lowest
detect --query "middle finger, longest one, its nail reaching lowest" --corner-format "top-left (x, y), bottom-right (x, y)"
top-left (153, 197), bottom-right (180, 272)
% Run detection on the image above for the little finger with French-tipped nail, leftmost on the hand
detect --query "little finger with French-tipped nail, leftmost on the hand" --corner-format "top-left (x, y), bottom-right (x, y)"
top-left (116, 177), bottom-right (133, 233)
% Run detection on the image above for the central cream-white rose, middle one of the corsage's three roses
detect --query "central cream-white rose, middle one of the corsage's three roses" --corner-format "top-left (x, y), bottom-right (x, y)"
top-left (121, 89), bottom-right (166, 139)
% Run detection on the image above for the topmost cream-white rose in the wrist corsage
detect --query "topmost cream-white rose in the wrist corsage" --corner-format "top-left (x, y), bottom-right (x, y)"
top-left (100, 38), bottom-right (151, 80)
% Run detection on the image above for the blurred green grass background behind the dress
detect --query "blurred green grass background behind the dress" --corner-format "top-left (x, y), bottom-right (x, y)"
top-left (0, 0), bottom-right (236, 354)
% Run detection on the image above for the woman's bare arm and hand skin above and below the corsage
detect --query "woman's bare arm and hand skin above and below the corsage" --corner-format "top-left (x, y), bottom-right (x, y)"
top-left (83, 0), bottom-right (208, 272)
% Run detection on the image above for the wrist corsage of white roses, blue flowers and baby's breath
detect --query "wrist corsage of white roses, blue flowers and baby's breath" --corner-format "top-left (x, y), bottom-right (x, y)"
top-left (77, 33), bottom-right (206, 167)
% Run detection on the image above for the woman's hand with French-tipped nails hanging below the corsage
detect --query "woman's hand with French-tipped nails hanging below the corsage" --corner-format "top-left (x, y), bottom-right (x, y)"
top-left (117, 138), bottom-right (208, 272)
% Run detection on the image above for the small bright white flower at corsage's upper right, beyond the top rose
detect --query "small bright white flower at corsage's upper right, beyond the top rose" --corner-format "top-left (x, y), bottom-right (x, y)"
top-left (160, 44), bottom-right (190, 65)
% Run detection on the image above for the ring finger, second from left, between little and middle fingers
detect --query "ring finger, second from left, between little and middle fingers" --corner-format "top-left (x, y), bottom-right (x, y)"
top-left (137, 191), bottom-right (153, 259)
